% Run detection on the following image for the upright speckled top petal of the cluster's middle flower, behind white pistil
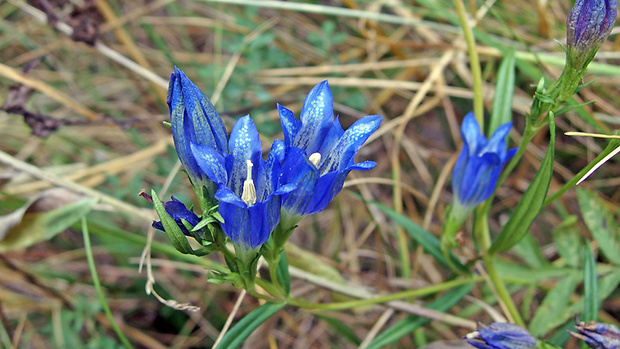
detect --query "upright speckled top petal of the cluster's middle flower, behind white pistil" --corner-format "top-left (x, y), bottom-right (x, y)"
top-left (227, 115), bottom-right (261, 196)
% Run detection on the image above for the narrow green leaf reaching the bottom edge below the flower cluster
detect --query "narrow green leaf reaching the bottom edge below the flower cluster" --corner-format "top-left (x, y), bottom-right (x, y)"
top-left (217, 302), bottom-right (284, 349)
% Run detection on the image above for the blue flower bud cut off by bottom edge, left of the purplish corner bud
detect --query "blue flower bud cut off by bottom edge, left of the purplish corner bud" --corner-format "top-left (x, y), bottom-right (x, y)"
top-left (464, 322), bottom-right (536, 349)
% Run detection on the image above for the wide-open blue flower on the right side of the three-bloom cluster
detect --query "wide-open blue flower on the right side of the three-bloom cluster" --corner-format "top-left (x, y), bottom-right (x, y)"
top-left (278, 81), bottom-right (382, 216)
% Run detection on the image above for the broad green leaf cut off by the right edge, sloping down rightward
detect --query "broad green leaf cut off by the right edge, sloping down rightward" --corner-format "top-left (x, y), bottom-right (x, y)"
top-left (577, 189), bottom-right (620, 265)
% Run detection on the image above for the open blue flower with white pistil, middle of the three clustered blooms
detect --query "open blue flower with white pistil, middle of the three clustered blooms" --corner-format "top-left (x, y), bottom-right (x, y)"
top-left (190, 115), bottom-right (295, 250)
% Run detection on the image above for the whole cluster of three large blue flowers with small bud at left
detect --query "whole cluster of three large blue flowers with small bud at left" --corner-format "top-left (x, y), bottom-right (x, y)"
top-left (153, 67), bottom-right (381, 250)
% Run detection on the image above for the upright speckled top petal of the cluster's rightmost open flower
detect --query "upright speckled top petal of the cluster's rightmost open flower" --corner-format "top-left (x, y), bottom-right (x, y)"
top-left (293, 80), bottom-right (334, 154)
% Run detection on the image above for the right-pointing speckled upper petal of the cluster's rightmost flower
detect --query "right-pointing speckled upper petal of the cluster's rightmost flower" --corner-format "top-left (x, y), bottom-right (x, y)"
top-left (320, 115), bottom-right (383, 174)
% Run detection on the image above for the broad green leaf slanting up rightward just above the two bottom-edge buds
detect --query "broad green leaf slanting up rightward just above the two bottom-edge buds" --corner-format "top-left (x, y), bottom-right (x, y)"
top-left (529, 273), bottom-right (581, 337)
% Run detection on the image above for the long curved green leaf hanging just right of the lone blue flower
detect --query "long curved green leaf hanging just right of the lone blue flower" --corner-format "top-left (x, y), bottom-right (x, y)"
top-left (489, 115), bottom-right (555, 253)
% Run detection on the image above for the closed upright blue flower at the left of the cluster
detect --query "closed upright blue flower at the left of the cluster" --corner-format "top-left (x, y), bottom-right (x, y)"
top-left (167, 67), bottom-right (228, 196)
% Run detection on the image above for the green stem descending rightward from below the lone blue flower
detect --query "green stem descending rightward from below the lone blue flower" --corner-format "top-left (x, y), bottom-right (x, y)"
top-left (474, 205), bottom-right (525, 327)
